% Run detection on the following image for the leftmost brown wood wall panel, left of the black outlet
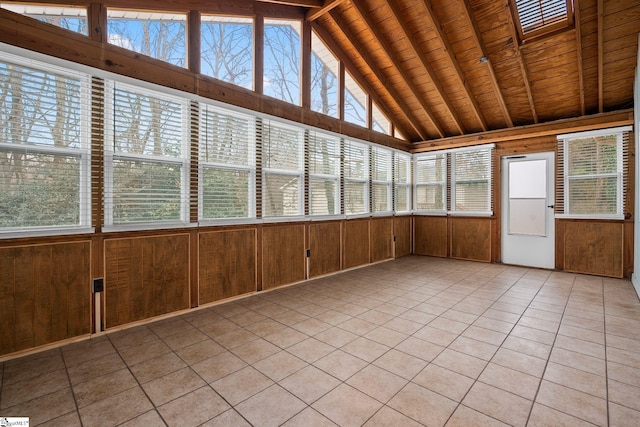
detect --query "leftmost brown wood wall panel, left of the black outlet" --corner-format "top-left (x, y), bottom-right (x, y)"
top-left (0, 240), bottom-right (91, 355)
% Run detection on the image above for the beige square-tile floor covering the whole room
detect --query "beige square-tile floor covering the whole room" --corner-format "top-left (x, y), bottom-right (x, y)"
top-left (0, 256), bottom-right (640, 427)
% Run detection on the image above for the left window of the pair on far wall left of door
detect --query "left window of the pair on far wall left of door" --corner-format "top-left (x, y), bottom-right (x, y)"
top-left (414, 153), bottom-right (447, 213)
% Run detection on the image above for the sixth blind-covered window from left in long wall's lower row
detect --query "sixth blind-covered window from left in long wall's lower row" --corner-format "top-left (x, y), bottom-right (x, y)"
top-left (344, 141), bottom-right (369, 215)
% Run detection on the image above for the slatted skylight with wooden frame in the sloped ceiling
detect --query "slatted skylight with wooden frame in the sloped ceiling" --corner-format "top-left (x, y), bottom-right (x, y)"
top-left (512, 0), bottom-right (573, 40)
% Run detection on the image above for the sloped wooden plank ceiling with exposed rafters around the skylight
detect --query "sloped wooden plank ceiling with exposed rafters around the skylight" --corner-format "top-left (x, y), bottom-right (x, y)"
top-left (263, 0), bottom-right (640, 142)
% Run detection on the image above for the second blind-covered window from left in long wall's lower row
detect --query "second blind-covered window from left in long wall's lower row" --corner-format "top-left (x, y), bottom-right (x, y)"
top-left (105, 82), bottom-right (189, 226)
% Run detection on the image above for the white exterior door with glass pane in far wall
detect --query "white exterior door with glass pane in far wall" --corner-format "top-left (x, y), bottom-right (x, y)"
top-left (502, 152), bottom-right (555, 269)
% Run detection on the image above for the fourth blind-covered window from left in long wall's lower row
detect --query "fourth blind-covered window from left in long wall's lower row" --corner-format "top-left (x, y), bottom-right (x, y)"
top-left (262, 120), bottom-right (304, 218)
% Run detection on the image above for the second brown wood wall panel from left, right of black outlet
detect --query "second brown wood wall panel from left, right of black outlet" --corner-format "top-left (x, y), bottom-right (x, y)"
top-left (104, 233), bottom-right (190, 328)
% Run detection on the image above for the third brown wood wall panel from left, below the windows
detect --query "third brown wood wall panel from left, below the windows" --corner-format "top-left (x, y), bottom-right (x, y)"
top-left (197, 228), bottom-right (258, 304)
